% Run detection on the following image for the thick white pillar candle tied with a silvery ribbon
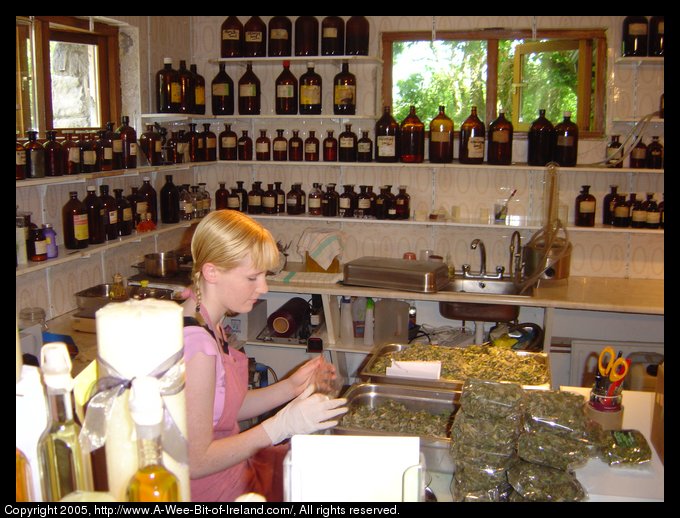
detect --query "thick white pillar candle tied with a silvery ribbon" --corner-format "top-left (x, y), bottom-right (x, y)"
top-left (95, 299), bottom-right (191, 501)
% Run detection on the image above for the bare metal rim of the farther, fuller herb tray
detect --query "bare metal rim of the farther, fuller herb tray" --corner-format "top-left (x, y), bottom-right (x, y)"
top-left (359, 344), bottom-right (552, 390)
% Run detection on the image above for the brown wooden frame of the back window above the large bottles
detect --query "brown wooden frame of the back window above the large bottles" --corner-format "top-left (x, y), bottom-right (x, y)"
top-left (381, 28), bottom-right (607, 138)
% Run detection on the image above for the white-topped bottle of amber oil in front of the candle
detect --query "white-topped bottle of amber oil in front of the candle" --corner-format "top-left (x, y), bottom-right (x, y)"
top-left (127, 376), bottom-right (179, 502)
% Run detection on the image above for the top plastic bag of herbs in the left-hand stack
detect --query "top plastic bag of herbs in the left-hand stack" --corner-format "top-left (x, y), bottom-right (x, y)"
top-left (460, 378), bottom-right (524, 418)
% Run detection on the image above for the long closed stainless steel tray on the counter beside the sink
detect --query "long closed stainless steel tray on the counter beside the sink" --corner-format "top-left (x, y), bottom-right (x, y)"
top-left (343, 257), bottom-right (449, 293)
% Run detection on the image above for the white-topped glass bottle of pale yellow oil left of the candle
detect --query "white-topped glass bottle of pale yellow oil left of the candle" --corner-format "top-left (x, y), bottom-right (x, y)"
top-left (38, 342), bottom-right (92, 502)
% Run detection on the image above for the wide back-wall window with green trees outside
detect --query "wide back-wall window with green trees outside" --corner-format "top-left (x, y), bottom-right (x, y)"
top-left (382, 29), bottom-right (607, 137)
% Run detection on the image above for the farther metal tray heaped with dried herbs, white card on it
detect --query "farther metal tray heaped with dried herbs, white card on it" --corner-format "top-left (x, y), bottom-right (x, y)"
top-left (360, 344), bottom-right (551, 391)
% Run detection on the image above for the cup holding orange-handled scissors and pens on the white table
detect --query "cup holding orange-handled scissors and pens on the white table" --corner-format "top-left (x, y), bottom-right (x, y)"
top-left (586, 347), bottom-right (630, 430)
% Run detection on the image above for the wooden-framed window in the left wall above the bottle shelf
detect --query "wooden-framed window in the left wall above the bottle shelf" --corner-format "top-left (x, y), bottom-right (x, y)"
top-left (16, 16), bottom-right (120, 137)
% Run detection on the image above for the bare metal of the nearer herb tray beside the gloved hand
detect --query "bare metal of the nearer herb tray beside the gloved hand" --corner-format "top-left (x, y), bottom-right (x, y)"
top-left (331, 383), bottom-right (460, 473)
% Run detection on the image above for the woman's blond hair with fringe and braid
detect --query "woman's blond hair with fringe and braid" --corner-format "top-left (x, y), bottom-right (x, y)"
top-left (191, 209), bottom-right (279, 312)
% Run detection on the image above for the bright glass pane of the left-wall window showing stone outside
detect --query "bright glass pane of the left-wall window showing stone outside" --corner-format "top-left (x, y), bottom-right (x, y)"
top-left (50, 41), bottom-right (101, 128)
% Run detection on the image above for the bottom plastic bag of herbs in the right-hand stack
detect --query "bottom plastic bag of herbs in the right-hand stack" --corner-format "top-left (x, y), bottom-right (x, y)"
top-left (507, 460), bottom-right (588, 502)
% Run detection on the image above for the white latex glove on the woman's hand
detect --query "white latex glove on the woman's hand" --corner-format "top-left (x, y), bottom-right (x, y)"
top-left (262, 384), bottom-right (347, 444)
